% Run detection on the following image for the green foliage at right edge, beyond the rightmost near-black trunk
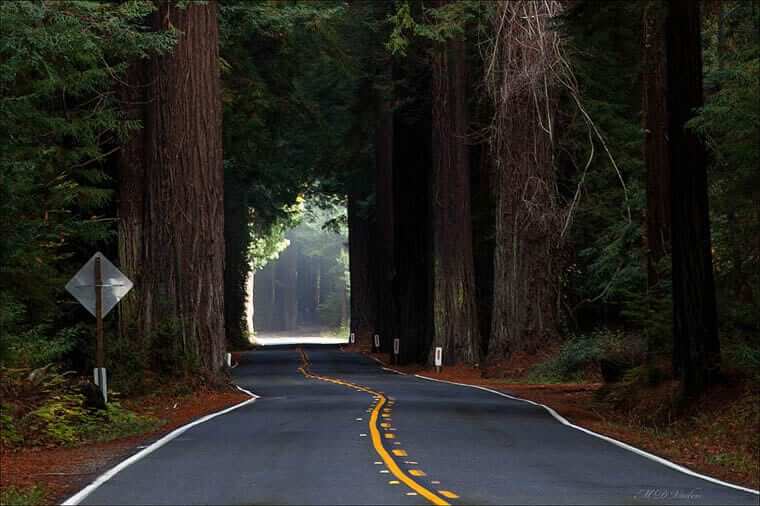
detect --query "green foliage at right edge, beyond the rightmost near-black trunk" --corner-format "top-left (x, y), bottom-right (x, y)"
top-left (689, 1), bottom-right (760, 335)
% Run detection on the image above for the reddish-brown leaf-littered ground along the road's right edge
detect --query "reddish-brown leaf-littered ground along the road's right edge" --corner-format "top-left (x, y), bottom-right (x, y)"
top-left (364, 350), bottom-right (760, 489)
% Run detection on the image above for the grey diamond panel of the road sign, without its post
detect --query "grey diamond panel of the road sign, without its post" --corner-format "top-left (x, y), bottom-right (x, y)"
top-left (66, 252), bottom-right (132, 316)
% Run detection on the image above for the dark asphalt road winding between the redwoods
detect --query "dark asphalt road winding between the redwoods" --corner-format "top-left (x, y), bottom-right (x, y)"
top-left (77, 346), bottom-right (758, 505)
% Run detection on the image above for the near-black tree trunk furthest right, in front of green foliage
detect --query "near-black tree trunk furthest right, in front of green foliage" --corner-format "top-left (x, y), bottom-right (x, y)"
top-left (665, 0), bottom-right (720, 396)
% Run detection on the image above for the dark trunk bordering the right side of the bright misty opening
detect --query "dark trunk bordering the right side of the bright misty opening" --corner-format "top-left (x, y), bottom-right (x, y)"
top-left (348, 193), bottom-right (377, 348)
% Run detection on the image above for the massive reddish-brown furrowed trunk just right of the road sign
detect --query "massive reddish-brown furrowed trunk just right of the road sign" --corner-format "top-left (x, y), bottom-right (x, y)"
top-left (142, 2), bottom-right (225, 374)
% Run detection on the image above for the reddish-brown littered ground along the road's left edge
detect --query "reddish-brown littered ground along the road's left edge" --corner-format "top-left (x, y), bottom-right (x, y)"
top-left (0, 387), bottom-right (249, 505)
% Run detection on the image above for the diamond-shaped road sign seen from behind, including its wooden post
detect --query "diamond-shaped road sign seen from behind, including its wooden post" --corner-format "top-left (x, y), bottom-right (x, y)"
top-left (66, 252), bottom-right (133, 402)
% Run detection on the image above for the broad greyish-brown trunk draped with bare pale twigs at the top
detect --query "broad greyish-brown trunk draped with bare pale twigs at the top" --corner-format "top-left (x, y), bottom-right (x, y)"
top-left (488, 1), bottom-right (560, 361)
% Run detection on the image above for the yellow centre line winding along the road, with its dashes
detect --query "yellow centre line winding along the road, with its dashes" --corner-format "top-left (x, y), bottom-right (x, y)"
top-left (298, 348), bottom-right (450, 506)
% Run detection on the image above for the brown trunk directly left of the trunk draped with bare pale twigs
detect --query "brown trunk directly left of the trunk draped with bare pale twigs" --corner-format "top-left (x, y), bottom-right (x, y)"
top-left (428, 10), bottom-right (479, 364)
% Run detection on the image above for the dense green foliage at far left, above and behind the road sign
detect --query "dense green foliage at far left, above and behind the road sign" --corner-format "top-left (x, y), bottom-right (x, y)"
top-left (0, 0), bottom-right (173, 372)
